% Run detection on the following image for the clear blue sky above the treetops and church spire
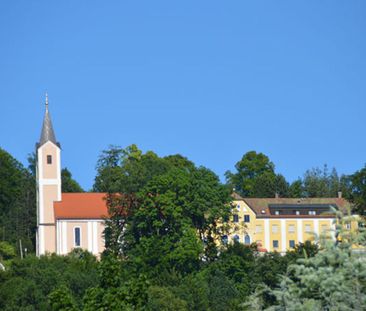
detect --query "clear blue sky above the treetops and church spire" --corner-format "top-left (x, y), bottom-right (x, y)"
top-left (0, 0), bottom-right (366, 190)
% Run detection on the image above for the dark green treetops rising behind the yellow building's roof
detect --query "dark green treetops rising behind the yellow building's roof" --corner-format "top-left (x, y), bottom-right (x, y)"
top-left (225, 151), bottom-right (354, 200)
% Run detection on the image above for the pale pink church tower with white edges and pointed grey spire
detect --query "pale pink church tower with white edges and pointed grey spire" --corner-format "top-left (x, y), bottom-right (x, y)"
top-left (36, 94), bottom-right (61, 256)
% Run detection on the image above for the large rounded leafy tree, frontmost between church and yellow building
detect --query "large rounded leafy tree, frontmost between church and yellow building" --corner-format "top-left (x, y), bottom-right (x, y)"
top-left (113, 168), bottom-right (230, 273)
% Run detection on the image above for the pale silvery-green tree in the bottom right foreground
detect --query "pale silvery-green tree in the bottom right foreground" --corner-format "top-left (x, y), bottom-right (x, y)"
top-left (246, 213), bottom-right (366, 311)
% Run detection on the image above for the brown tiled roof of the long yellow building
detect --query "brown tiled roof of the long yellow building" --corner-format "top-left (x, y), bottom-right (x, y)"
top-left (233, 194), bottom-right (351, 218)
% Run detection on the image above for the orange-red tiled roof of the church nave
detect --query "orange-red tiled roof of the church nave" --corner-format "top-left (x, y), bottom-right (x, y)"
top-left (54, 192), bottom-right (108, 219)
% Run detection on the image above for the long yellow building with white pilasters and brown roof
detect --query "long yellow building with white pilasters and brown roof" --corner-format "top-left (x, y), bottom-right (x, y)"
top-left (229, 193), bottom-right (350, 252)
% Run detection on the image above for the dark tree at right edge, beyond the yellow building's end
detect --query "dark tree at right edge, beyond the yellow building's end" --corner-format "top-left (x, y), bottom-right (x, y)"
top-left (349, 166), bottom-right (366, 216)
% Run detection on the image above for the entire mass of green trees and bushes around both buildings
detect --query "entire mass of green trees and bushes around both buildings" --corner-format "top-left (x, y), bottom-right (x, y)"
top-left (0, 145), bottom-right (366, 311)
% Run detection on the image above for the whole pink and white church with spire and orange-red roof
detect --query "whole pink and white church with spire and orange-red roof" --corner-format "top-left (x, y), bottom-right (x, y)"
top-left (36, 97), bottom-right (108, 256)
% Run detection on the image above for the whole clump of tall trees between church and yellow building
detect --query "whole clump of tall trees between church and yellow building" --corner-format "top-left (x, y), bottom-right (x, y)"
top-left (96, 146), bottom-right (231, 273)
